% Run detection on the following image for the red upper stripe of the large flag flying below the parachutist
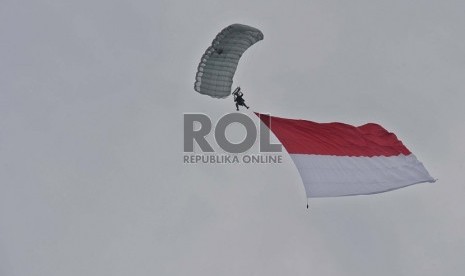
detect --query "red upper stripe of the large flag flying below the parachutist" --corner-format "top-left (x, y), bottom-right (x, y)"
top-left (255, 113), bottom-right (411, 157)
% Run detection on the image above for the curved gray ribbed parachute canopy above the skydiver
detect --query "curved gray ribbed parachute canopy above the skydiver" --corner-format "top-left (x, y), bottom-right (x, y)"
top-left (194, 24), bottom-right (263, 98)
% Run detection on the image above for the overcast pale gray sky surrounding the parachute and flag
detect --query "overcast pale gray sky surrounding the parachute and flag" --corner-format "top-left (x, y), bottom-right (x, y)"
top-left (0, 0), bottom-right (465, 276)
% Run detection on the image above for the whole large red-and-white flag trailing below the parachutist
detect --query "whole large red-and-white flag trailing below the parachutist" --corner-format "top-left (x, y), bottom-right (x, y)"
top-left (256, 113), bottom-right (435, 197)
